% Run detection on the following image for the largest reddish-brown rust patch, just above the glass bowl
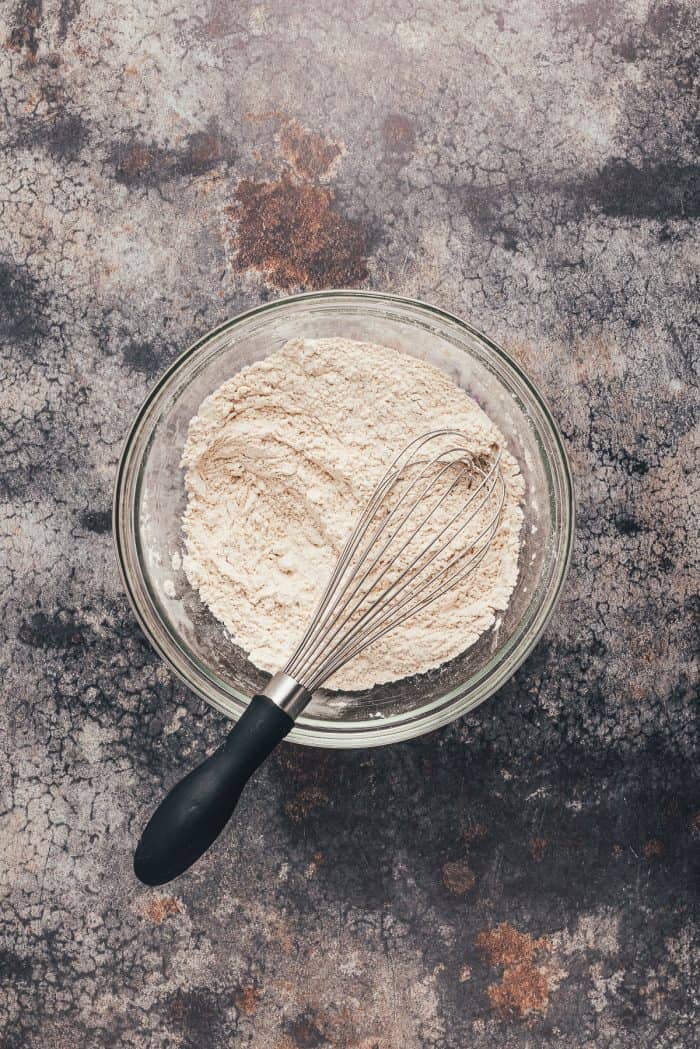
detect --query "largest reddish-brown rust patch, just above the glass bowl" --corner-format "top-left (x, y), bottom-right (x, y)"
top-left (226, 177), bottom-right (368, 291)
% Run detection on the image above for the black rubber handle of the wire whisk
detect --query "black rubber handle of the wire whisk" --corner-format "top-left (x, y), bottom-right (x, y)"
top-left (133, 695), bottom-right (294, 885)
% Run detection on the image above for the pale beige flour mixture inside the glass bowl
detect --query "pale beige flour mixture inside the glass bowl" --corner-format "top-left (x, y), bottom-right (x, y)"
top-left (183, 339), bottom-right (524, 690)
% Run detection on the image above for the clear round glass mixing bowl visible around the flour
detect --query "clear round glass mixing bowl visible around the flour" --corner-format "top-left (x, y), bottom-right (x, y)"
top-left (114, 292), bottom-right (574, 747)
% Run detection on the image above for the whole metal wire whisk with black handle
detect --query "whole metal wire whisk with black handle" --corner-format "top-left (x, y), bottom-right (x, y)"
top-left (134, 429), bottom-right (506, 885)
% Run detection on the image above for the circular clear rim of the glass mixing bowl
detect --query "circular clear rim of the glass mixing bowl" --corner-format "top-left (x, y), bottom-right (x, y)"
top-left (112, 288), bottom-right (576, 748)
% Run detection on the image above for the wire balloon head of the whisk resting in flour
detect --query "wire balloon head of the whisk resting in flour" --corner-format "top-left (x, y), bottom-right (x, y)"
top-left (284, 429), bottom-right (506, 692)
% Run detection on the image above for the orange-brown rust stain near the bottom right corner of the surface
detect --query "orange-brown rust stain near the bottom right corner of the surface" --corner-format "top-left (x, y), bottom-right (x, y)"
top-left (476, 922), bottom-right (550, 1018)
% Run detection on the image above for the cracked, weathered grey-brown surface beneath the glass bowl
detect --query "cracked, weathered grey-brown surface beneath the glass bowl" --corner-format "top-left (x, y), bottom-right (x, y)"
top-left (0, 0), bottom-right (700, 1049)
